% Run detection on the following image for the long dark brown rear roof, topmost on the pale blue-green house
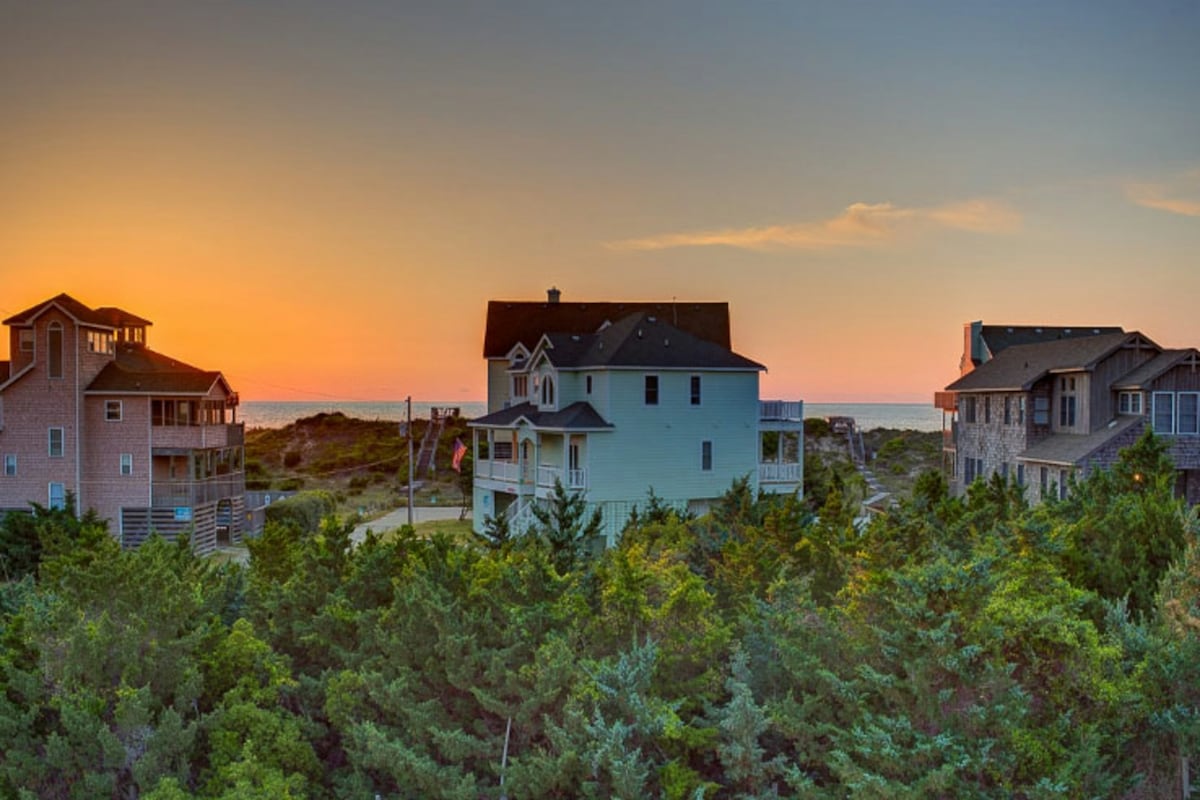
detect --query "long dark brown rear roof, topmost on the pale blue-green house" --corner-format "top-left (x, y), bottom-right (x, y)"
top-left (484, 300), bottom-right (731, 359)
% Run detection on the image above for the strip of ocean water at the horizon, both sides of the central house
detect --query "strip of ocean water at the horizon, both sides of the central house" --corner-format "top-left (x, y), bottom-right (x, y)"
top-left (238, 401), bottom-right (942, 431)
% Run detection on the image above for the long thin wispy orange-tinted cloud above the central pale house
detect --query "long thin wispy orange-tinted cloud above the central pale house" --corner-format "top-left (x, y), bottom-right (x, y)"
top-left (608, 199), bottom-right (1021, 251)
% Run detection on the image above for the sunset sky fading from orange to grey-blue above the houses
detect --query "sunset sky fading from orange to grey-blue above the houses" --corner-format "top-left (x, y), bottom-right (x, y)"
top-left (0, 0), bottom-right (1200, 402)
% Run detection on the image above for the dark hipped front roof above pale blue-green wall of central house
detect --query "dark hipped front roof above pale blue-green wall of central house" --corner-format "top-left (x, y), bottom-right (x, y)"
top-left (540, 311), bottom-right (766, 371)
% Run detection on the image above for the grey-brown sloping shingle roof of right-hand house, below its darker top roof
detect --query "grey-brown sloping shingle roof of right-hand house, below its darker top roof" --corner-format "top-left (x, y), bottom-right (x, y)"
top-left (946, 331), bottom-right (1157, 392)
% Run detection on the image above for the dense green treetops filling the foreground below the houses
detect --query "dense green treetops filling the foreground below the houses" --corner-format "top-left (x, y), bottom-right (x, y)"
top-left (0, 437), bottom-right (1200, 800)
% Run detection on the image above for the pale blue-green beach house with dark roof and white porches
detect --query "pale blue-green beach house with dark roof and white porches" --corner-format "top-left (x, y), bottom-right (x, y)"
top-left (470, 289), bottom-right (804, 545)
